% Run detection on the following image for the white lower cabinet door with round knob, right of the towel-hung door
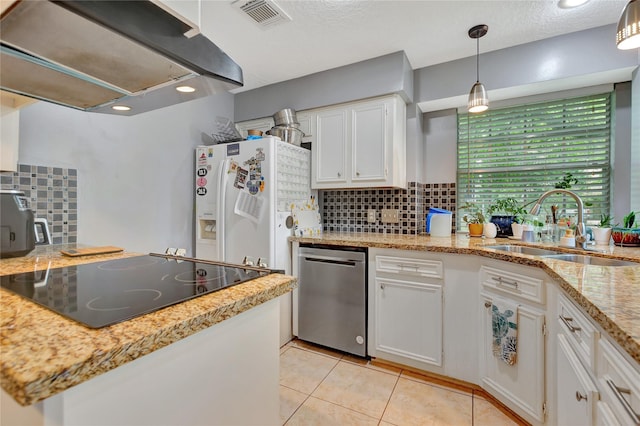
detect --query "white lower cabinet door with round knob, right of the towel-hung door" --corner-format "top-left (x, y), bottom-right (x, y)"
top-left (556, 334), bottom-right (599, 426)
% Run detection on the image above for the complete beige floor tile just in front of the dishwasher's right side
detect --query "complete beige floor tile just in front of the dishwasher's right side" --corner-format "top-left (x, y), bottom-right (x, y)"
top-left (312, 361), bottom-right (398, 419)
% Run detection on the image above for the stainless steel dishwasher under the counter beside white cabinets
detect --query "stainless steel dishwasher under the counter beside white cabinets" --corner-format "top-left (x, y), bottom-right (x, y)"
top-left (298, 246), bottom-right (367, 357)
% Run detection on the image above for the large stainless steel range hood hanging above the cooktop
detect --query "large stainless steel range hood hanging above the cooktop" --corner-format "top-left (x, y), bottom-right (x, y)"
top-left (0, 0), bottom-right (243, 115)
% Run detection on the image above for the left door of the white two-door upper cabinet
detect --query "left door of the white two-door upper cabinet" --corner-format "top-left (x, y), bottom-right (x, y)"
top-left (311, 109), bottom-right (347, 188)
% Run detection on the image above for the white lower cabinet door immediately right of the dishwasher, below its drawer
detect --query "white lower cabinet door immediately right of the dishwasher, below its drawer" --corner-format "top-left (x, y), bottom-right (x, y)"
top-left (375, 277), bottom-right (442, 366)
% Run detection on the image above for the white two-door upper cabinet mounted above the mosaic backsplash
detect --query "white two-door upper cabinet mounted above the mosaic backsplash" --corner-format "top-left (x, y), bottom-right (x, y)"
top-left (311, 95), bottom-right (407, 189)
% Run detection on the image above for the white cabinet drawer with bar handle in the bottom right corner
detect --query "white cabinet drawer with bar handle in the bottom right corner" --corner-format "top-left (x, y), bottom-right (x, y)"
top-left (598, 339), bottom-right (640, 425)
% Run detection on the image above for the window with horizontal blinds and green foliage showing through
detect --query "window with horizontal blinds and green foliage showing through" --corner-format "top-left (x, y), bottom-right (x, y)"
top-left (457, 93), bottom-right (612, 225)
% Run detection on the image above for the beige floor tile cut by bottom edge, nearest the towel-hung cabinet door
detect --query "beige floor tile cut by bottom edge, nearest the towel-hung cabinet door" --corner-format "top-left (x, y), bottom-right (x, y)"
top-left (382, 377), bottom-right (472, 426)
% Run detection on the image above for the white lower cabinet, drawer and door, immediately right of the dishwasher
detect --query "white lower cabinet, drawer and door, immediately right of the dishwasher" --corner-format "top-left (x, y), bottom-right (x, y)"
top-left (369, 251), bottom-right (443, 368)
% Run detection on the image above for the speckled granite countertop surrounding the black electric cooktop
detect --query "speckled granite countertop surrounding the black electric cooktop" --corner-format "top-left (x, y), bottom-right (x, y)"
top-left (0, 245), bottom-right (296, 405)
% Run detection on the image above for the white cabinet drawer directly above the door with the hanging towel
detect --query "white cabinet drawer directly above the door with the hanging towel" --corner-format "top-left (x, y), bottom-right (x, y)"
top-left (480, 266), bottom-right (544, 303)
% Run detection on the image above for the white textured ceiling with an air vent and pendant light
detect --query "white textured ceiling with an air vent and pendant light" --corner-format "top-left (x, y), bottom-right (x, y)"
top-left (194, 0), bottom-right (627, 92)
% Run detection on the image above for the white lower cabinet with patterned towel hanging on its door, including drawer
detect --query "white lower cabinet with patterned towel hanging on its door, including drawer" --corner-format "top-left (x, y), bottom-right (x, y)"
top-left (480, 264), bottom-right (546, 424)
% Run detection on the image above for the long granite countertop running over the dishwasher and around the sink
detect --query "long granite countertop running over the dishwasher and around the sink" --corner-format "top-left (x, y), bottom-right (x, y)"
top-left (291, 233), bottom-right (640, 363)
